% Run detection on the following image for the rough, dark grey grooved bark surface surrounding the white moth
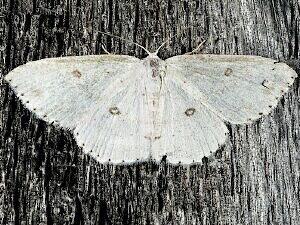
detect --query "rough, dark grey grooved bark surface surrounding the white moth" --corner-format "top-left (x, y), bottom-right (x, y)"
top-left (0, 0), bottom-right (300, 225)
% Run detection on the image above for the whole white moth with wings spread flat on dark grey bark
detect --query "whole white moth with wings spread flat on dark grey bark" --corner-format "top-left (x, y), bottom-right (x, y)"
top-left (5, 40), bottom-right (297, 164)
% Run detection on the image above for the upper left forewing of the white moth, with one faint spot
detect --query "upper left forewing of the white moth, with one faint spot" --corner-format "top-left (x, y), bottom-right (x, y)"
top-left (5, 55), bottom-right (140, 129)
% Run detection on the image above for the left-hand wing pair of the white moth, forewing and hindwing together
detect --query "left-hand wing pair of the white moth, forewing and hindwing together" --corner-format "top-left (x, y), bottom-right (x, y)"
top-left (5, 55), bottom-right (149, 162)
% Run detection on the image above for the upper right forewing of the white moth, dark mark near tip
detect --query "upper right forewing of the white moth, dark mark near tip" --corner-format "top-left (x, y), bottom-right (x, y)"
top-left (166, 55), bottom-right (297, 124)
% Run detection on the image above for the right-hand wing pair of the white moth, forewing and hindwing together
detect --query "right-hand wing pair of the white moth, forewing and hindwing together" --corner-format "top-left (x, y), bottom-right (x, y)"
top-left (153, 55), bottom-right (297, 163)
